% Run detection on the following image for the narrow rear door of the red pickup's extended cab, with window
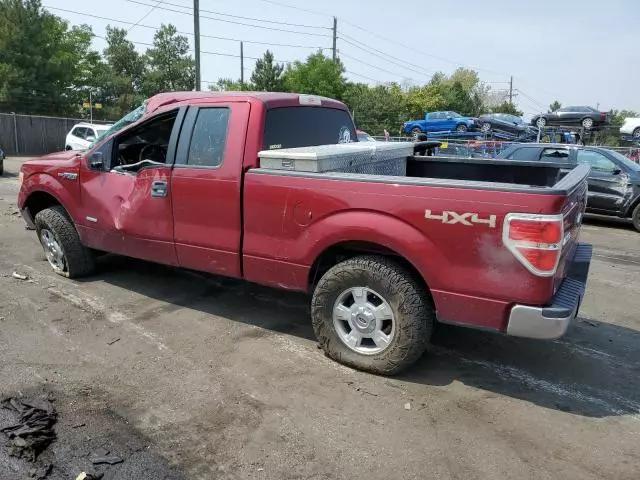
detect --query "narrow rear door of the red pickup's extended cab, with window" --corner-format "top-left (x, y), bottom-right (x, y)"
top-left (171, 102), bottom-right (250, 276)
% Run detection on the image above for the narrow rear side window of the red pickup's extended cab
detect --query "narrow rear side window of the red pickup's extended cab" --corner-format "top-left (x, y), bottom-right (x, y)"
top-left (187, 107), bottom-right (229, 167)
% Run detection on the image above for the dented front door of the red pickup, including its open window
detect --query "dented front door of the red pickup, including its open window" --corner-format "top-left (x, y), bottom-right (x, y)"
top-left (79, 109), bottom-right (184, 265)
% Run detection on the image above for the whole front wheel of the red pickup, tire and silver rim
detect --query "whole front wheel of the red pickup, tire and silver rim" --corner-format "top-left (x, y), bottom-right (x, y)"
top-left (34, 206), bottom-right (95, 278)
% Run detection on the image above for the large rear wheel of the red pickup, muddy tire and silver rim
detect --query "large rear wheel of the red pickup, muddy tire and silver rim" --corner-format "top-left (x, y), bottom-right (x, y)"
top-left (311, 256), bottom-right (435, 375)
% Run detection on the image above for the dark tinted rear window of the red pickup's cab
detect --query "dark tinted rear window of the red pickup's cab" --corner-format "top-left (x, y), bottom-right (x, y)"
top-left (264, 107), bottom-right (358, 150)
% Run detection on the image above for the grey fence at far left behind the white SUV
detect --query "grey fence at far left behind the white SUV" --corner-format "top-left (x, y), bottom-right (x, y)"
top-left (0, 113), bottom-right (107, 155)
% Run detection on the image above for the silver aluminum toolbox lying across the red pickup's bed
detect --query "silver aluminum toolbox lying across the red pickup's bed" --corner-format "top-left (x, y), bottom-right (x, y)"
top-left (258, 142), bottom-right (414, 176)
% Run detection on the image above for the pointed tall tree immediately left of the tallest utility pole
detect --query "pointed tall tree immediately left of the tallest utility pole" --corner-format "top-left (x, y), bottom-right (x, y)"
top-left (142, 25), bottom-right (195, 97)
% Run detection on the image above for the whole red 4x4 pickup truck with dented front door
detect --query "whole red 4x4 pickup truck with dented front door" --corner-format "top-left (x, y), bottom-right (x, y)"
top-left (18, 92), bottom-right (591, 374)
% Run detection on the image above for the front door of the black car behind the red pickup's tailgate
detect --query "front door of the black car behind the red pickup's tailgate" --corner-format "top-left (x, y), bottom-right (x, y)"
top-left (577, 150), bottom-right (627, 213)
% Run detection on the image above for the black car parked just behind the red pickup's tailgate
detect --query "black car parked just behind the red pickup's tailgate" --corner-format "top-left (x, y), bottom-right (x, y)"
top-left (499, 143), bottom-right (640, 231)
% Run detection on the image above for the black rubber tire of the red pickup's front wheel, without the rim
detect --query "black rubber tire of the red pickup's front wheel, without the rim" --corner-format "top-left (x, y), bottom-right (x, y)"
top-left (34, 206), bottom-right (95, 278)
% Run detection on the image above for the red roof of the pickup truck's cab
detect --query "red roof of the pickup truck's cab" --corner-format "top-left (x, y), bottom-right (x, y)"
top-left (147, 92), bottom-right (347, 113)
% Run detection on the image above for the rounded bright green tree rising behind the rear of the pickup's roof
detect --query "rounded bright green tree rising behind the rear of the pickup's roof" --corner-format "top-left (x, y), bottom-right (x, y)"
top-left (284, 51), bottom-right (347, 100)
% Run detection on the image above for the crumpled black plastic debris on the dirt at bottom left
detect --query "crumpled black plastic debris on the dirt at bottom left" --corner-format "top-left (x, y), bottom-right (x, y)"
top-left (0, 398), bottom-right (57, 462)
